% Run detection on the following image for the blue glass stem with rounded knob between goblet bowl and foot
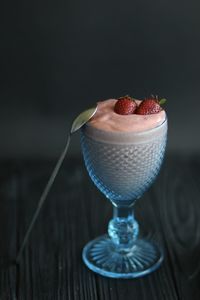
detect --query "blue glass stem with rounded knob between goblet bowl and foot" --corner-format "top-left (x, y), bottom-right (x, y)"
top-left (108, 206), bottom-right (139, 249)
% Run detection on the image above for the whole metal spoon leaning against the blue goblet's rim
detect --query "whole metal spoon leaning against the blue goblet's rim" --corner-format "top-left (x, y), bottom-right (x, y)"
top-left (16, 106), bottom-right (97, 263)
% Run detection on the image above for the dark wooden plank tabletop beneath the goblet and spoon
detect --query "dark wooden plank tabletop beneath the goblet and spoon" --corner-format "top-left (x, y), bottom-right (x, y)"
top-left (0, 154), bottom-right (200, 300)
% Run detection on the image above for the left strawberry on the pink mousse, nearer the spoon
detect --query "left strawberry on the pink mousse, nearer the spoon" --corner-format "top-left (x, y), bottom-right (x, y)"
top-left (114, 95), bottom-right (137, 115)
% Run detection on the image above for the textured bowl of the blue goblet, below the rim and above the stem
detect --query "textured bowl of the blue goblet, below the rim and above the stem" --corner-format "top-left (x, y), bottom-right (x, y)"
top-left (81, 131), bottom-right (166, 203)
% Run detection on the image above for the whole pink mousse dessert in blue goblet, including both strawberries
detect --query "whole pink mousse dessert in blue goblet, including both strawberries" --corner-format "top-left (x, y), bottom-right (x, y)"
top-left (81, 96), bottom-right (167, 278)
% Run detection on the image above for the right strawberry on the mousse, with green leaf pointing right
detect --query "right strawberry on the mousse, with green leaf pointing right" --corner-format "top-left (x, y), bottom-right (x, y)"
top-left (135, 96), bottom-right (166, 115)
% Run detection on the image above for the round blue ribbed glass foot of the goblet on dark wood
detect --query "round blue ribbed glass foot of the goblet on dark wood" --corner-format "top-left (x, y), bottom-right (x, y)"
top-left (83, 235), bottom-right (163, 278)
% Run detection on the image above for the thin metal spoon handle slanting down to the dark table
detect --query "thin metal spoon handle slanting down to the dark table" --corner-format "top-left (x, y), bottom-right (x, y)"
top-left (16, 134), bottom-right (71, 263)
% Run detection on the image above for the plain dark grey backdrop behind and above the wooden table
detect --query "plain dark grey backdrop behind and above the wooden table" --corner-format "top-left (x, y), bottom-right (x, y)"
top-left (0, 0), bottom-right (200, 158)
